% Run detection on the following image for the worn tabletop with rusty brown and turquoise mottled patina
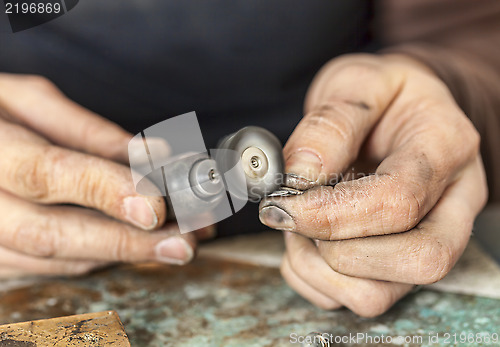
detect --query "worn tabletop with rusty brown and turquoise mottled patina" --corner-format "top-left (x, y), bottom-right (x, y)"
top-left (0, 259), bottom-right (500, 347)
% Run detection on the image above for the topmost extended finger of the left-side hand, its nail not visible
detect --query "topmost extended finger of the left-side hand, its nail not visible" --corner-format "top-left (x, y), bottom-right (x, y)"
top-left (0, 73), bottom-right (132, 162)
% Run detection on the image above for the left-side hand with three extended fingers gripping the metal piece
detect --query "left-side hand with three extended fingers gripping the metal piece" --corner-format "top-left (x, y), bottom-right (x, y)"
top-left (0, 74), bottom-right (210, 277)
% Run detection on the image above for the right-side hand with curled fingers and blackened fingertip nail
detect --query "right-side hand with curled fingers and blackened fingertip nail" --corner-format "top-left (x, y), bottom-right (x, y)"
top-left (260, 54), bottom-right (487, 316)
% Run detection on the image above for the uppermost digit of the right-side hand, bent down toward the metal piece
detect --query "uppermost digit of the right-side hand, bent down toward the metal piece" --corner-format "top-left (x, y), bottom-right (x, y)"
top-left (284, 55), bottom-right (403, 186)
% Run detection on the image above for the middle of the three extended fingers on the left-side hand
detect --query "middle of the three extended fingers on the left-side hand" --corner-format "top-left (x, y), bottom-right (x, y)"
top-left (0, 121), bottom-right (167, 230)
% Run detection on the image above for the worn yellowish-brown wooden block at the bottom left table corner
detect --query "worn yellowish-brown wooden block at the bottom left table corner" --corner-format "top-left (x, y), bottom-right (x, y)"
top-left (0, 311), bottom-right (130, 347)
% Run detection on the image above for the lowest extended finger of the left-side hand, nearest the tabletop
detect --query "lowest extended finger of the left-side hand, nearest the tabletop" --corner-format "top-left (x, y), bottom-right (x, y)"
top-left (0, 195), bottom-right (196, 265)
